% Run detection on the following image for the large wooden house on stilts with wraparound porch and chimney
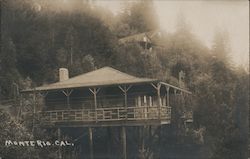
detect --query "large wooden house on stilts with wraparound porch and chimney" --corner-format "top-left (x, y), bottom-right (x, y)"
top-left (22, 67), bottom-right (191, 158)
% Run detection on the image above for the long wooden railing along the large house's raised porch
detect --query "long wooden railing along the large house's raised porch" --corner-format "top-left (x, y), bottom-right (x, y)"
top-left (38, 106), bottom-right (171, 123)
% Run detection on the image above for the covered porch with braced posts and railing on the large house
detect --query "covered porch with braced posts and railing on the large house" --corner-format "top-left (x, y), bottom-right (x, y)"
top-left (37, 82), bottom-right (174, 126)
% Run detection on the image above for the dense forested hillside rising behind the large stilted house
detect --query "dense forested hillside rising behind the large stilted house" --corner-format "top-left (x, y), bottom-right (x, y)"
top-left (0, 0), bottom-right (249, 159)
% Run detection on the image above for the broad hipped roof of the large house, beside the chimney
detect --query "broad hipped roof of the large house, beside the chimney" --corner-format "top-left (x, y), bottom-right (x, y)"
top-left (23, 67), bottom-right (158, 92)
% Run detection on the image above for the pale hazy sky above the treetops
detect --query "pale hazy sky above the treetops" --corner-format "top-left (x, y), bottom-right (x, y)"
top-left (96, 0), bottom-right (249, 68)
